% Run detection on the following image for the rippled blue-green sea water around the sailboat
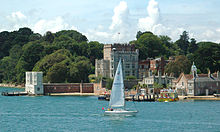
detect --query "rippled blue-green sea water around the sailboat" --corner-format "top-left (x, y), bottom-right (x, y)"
top-left (0, 88), bottom-right (220, 132)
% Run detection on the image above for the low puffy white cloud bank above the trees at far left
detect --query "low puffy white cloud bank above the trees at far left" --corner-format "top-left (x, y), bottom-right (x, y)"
top-left (0, 10), bottom-right (77, 35)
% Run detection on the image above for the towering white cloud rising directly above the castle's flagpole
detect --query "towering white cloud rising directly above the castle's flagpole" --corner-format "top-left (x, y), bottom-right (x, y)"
top-left (88, 1), bottom-right (137, 43)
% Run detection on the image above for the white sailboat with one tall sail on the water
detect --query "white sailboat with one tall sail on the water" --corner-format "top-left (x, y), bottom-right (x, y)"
top-left (105, 59), bottom-right (138, 115)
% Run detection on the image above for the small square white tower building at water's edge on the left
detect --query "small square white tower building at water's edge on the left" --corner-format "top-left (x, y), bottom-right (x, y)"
top-left (25, 72), bottom-right (44, 95)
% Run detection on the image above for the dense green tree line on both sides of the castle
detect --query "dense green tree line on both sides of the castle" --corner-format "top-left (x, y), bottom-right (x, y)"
top-left (0, 27), bottom-right (220, 84)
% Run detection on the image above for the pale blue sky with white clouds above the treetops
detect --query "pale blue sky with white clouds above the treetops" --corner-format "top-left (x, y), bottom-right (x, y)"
top-left (0, 0), bottom-right (220, 43)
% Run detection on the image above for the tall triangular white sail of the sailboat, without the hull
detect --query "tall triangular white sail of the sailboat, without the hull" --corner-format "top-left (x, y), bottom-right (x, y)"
top-left (109, 59), bottom-right (125, 107)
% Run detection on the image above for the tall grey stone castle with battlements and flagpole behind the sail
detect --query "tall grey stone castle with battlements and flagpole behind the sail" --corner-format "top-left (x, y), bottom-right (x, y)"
top-left (95, 44), bottom-right (139, 78)
